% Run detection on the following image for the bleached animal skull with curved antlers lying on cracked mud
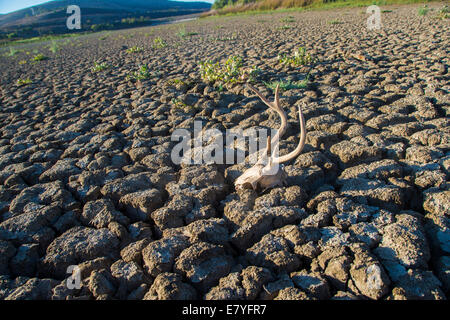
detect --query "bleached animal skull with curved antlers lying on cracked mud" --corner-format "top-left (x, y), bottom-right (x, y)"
top-left (234, 85), bottom-right (306, 190)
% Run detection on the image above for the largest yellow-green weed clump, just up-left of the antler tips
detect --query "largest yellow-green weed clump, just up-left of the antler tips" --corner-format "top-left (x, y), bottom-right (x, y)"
top-left (199, 56), bottom-right (260, 86)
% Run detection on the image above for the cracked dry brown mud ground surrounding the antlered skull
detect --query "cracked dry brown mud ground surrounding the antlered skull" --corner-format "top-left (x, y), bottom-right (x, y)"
top-left (0, 4), bottom-right (450, 299)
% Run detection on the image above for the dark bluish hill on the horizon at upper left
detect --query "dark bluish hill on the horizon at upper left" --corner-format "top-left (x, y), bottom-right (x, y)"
top-left (0, 0), bottom-right (211, 37)
